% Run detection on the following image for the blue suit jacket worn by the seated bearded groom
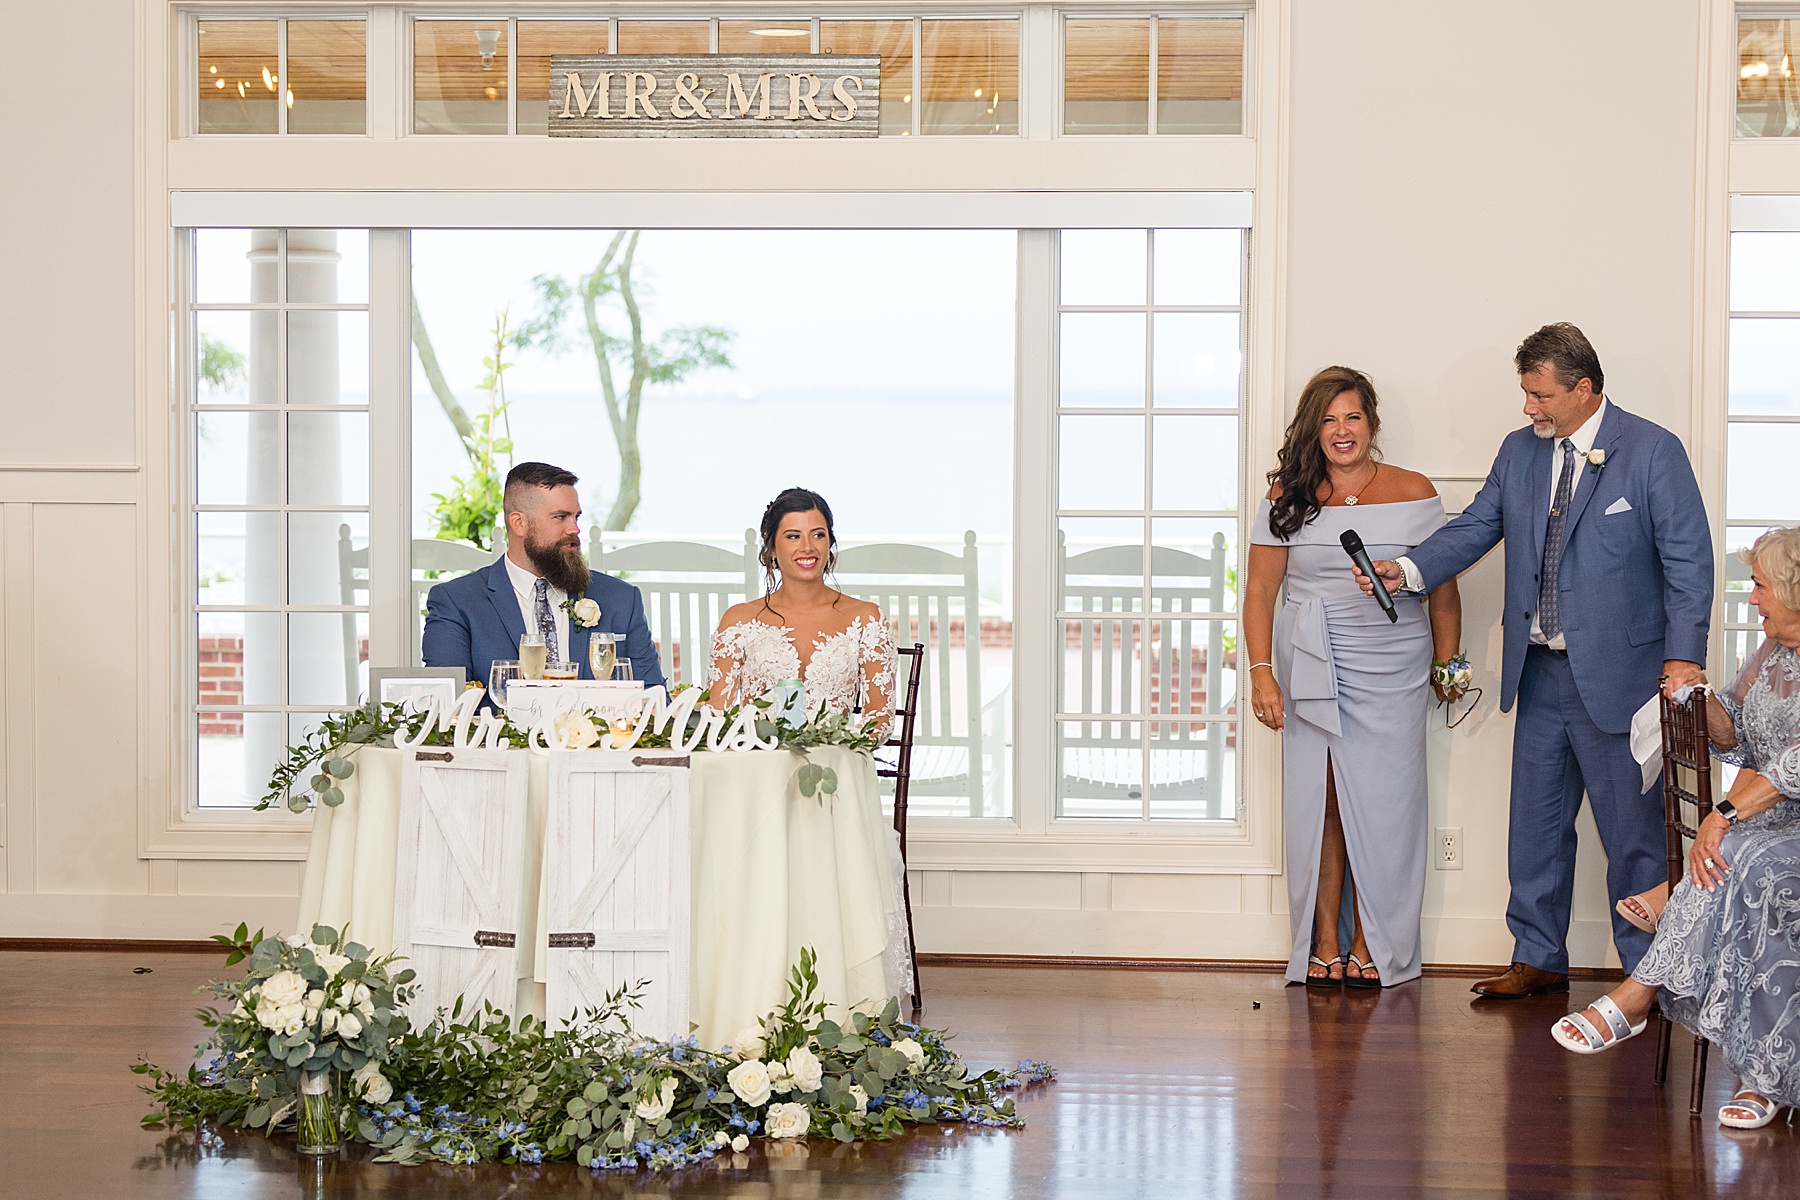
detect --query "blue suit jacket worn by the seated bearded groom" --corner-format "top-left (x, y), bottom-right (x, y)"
top-left (421, 554), bottom-right (662, 687)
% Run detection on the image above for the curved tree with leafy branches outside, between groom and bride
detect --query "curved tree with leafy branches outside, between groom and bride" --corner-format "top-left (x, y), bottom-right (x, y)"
top-left (518, 228), bottom-right (734, 529)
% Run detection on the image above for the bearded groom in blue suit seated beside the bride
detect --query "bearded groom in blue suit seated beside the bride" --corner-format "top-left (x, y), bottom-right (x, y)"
top-left (423, 462), bottom-right (662, 705)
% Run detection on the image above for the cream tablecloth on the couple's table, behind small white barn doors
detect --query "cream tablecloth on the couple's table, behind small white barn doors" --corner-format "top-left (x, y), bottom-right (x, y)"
top-left (295, 747), bottom-right (909, 1049)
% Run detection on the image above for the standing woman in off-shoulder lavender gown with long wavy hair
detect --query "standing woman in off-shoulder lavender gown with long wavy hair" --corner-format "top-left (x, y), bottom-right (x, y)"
top-left (1244, 367), bottom-right (1462, 988)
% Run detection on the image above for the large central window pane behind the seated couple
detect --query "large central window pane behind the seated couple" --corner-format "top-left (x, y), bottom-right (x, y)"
top-left (412, 230), bottom-right (1019, 817)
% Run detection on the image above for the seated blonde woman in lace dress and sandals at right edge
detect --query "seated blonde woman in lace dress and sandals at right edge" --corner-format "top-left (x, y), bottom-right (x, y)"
top-left (1552, 529), bottom-right (1800, 1130)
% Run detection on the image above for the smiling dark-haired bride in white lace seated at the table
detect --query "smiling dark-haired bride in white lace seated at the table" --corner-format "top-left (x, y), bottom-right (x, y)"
top-left (707, 488), bottom-right (895, 743)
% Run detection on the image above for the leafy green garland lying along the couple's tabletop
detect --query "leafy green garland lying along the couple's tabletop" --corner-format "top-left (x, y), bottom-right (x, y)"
top-left (256, 685), bottom-right (880, 813)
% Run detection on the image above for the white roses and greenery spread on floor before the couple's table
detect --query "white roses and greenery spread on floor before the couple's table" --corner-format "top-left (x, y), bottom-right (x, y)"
top-left (133, 925), bottom-right (1057, 1171)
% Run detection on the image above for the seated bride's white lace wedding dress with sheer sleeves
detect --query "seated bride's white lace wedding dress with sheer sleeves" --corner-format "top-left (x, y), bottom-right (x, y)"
top-left (707, 617), bottom-right (913, 1002)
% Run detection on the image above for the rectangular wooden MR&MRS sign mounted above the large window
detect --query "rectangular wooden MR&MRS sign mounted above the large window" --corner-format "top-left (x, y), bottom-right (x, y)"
top-left (549, 54), bottom-right (882, 137)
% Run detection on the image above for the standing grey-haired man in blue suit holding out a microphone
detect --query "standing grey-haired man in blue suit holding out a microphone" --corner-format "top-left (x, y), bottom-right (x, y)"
top-left (1357, 322), bottom-right (1714, 997)
